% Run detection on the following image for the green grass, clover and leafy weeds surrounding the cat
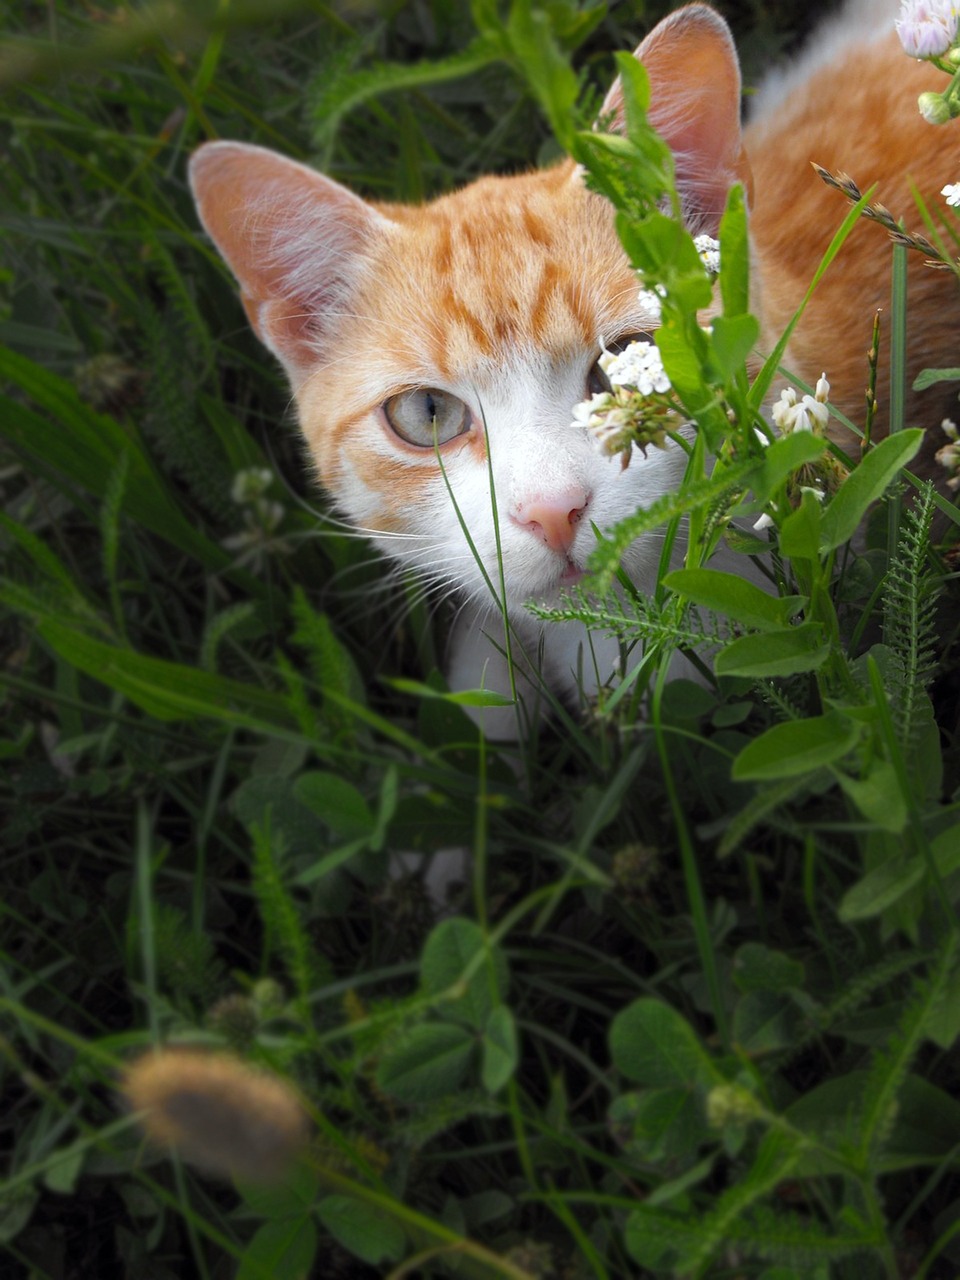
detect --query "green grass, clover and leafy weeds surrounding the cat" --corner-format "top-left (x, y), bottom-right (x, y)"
top-left (0, 0), bottom-right (960, 1280)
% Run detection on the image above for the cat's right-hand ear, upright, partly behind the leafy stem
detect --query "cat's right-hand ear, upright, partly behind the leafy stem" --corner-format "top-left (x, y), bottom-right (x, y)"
top-left (600, 4), bottom-right (750, 236)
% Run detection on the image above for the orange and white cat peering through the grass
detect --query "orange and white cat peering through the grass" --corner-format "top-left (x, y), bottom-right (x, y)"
top-left (191, 0), bottom-right (960, 736)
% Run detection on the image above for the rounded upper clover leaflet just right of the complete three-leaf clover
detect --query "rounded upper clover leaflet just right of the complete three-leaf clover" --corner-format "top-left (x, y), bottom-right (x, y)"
top-left (609, 997), bottom-right (722, 1089)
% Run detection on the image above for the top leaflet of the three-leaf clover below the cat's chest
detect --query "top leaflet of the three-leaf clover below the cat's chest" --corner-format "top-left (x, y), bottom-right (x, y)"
top-left (420, 916), bottom-right (509, 1030)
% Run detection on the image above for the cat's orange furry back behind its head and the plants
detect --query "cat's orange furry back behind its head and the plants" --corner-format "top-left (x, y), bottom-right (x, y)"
top-left (745, 0), bottom-right (960, 460)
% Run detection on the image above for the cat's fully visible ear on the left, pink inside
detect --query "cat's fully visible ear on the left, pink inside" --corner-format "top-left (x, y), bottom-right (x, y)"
top-left (189, 142), bottom-right (392, 388)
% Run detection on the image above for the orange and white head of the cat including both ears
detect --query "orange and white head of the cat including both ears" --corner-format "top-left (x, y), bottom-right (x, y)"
top-left (191, 5), bottom-right (744, 605)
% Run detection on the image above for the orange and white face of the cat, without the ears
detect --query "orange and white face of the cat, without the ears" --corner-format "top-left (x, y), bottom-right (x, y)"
top-left (291, 166), bottom-right (684, 605)
